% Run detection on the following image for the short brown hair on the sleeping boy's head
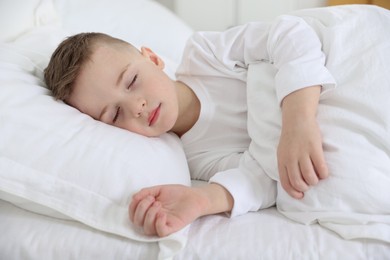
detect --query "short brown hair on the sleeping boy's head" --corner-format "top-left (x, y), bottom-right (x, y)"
top-left (44, 32), bottom-right (135, 101)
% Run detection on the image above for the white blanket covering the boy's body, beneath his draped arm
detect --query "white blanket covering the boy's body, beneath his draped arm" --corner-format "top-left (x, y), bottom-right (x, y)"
top-left (248, 5), bottom-right (390, 243)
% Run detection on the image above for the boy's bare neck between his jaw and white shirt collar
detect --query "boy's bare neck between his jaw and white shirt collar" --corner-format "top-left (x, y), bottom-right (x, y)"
top-left (172, 81), bottom-right (200, 136)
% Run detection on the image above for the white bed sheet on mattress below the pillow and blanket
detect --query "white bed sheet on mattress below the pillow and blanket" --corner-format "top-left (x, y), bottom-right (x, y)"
top-left (0, 197), bottom-right (390, 260)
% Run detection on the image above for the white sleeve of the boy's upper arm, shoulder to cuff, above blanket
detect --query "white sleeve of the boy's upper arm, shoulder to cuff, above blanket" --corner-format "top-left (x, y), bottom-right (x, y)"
top-left (194, 15), bottom-right (336, 103)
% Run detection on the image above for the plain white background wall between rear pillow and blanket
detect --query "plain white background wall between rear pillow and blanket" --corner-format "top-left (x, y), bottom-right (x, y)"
top-left (157, 0), bottom-right (327, 30)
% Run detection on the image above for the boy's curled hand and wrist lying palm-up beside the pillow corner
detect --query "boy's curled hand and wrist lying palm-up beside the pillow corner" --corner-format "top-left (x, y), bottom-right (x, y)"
top-left (129, 183), bottom-right (233, 237)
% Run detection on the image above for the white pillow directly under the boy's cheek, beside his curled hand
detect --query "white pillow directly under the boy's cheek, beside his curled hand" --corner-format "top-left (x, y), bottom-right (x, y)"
top-left (0, 40), bottom-right (190, 256)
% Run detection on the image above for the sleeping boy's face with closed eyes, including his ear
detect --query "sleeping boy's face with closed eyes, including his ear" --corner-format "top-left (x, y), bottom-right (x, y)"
top-left (67, 45), bottom-right (179, 137)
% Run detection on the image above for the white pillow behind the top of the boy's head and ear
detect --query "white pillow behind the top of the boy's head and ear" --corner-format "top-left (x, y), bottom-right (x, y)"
top-left (53, 0), bottom-right (192, 62)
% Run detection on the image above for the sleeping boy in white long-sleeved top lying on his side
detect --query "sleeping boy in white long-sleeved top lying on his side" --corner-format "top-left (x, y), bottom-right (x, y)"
top-left (45, 5), bottom-right (390, 239)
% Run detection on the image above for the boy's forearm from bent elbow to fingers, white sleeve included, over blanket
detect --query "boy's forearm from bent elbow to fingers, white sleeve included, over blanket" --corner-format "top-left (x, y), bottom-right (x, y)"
top-left (267, 16), bottom-right (335, 198)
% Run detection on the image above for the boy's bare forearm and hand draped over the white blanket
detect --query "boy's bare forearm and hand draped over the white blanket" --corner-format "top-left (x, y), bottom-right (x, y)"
top-left (277, 86), bottom-right (328, 199)
